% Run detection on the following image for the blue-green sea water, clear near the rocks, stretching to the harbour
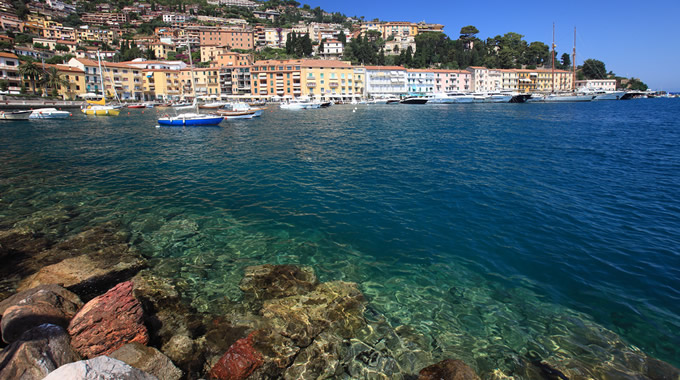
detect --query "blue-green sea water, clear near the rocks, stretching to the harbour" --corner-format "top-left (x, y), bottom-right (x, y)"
top-left (0, 99), bottom-right (680, 373)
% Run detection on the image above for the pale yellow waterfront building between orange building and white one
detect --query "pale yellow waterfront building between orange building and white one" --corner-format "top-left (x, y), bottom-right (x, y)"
top-left (300, 59), bottom-right (364, 100)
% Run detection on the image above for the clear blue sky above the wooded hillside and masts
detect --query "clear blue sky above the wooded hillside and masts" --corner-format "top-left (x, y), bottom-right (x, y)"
top-left (306, 0), bottom-right (680, 91)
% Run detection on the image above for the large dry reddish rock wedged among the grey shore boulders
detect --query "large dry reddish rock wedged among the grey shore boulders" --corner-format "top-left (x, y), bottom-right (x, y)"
top-left (68, 281), bottom-right (149, 358)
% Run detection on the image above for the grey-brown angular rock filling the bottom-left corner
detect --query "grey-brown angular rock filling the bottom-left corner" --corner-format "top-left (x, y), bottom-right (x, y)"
top-left (0, 324), bottom-right (80, 380)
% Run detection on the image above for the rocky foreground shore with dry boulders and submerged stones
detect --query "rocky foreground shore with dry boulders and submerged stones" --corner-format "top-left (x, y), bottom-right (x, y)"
top-left (0, 221), bottom-right (680, 380)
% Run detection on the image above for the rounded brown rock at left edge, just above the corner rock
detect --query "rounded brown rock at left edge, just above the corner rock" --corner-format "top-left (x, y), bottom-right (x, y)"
top-left (0, 285), bottom-right (83, 343)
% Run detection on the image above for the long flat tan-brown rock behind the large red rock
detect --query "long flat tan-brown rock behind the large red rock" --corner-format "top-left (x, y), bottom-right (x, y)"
top-left (17, 244), bottom-right (146, 299)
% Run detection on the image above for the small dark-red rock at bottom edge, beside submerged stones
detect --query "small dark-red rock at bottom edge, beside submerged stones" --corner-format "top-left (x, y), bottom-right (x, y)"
top-left (210, 332), bottom-right (263, 380)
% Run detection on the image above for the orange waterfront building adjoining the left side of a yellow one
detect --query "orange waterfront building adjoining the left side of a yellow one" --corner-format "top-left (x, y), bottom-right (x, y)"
top-left (251, 60), bottom-right (302, 98)
